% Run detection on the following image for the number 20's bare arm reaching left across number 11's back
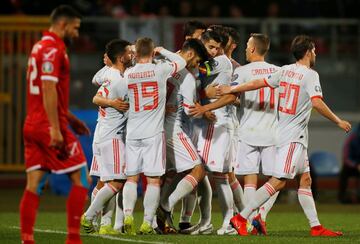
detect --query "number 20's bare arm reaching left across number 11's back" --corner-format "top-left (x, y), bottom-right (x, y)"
top-left (216, 79), bottom-right (269, 96)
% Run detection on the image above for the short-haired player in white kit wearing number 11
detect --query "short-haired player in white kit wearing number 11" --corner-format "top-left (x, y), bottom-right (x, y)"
top-left (232, 33), bottom-right (279, 235)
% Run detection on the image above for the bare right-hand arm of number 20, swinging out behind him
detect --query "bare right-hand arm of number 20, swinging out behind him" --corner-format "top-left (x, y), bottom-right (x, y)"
top-left (311, 97), bottom-right (351, 132)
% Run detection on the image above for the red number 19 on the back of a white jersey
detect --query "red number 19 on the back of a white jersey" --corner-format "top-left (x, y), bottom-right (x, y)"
top-left (128, 81), bottom-right (159, 112)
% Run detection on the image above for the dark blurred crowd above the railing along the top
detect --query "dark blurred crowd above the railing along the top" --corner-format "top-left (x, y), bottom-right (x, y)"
top-left (0, 0), bottom-right (360, 18)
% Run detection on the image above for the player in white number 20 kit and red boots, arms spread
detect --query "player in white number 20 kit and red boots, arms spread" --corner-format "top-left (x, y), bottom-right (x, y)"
top-left (218, 35), bottom-right (351, 237)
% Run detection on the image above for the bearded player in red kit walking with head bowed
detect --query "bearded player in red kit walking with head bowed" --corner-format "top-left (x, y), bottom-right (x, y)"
top-left (20, 5), bottom-right (89, 243)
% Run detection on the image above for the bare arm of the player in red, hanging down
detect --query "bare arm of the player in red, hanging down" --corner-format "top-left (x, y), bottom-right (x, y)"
top-left (42, 80), bottom-right (64, 148)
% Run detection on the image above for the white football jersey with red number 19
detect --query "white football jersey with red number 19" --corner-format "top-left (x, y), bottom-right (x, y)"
top-left (125, 60), bottom-right (180, 139)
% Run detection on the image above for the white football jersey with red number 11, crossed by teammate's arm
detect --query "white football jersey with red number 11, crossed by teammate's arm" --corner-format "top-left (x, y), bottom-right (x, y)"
top-left (232, 61), bottom-right (279, 146)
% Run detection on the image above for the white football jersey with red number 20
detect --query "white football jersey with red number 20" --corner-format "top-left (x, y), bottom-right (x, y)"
top-left (265, 63), bottom-right (322, 148)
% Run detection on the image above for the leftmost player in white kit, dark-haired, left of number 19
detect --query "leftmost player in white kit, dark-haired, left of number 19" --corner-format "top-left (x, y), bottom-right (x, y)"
top-left (81, 40), bottom-right (132, 234)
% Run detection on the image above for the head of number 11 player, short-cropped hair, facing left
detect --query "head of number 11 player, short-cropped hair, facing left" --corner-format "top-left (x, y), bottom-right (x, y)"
top-left (245, 33), bottom-right (270, 62)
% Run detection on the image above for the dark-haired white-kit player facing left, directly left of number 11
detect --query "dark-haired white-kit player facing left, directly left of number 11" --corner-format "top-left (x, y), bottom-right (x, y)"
top-left (190, 30), bottom-right (236, 235)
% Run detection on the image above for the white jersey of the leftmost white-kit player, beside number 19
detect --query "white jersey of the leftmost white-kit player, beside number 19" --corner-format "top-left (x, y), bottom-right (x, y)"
top-left (94, 67), bottom-right (127, 143)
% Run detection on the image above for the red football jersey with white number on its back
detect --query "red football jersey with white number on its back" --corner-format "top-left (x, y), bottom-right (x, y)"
top-left (25, 31), bottom-right (70, 128)
